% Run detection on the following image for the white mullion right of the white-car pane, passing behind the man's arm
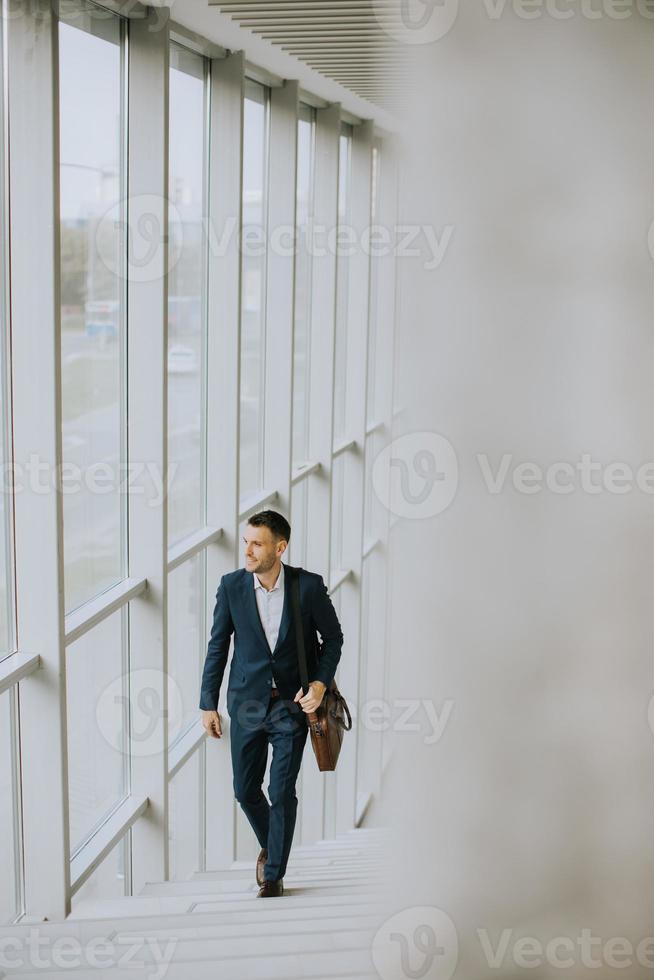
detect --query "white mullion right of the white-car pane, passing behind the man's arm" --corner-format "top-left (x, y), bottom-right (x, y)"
top-left (204, 52), bottom-right (245, 869)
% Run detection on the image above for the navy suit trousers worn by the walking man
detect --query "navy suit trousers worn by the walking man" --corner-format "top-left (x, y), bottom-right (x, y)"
top-left (230, 697), bottom-right (309, 880)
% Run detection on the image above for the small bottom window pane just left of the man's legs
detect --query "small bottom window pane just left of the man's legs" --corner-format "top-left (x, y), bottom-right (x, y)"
top-left (169, 746), bottom-right (204, 881)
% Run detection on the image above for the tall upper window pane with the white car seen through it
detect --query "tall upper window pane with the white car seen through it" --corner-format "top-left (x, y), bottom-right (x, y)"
top-left (168, 45), bottom-right (207, 544)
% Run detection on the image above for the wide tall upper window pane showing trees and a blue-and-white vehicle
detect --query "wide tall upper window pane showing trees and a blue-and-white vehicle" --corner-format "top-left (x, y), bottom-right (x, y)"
top-left (59, 4), bottom-right (126, 610)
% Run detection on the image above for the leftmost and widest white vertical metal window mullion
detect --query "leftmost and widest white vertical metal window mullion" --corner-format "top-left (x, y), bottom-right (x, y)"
top-left (6, 0), bottom-right (70, 919)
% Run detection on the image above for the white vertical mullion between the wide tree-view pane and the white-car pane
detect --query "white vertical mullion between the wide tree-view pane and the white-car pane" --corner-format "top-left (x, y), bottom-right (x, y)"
top-left (128, 8), bottom-right (170, 892)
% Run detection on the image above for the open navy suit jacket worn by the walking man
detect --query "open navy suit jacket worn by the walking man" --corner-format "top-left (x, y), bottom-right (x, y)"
top-left (200, 564), bottom-right (343, 715)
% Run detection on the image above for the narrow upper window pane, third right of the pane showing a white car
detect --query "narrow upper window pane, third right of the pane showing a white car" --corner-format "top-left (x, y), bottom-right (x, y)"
top-left (334, 126), bottom-right (352, 440)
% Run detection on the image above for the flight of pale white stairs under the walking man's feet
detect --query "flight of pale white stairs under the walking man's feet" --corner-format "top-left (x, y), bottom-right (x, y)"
top-left (46, 828), bottom-right (392, 980)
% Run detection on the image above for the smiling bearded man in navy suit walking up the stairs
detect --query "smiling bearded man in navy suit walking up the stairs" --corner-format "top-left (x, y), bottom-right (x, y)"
top-left (200, 510), bottom-right (343, 897)
